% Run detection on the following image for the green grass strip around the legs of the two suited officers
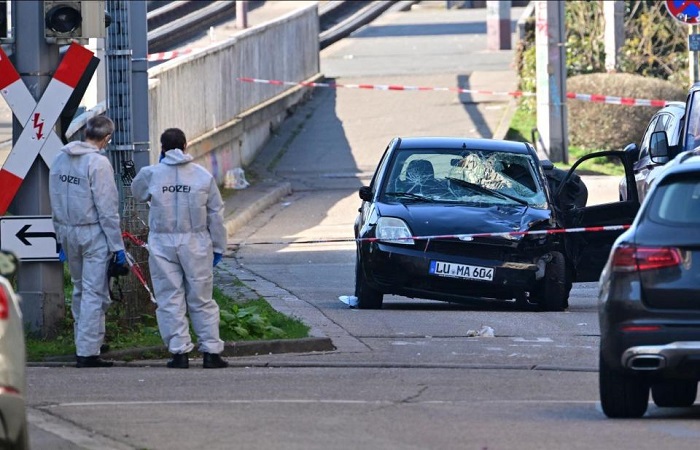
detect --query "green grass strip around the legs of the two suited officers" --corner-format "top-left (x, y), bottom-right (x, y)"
top-left (26, 271), bottom-right (309, 361)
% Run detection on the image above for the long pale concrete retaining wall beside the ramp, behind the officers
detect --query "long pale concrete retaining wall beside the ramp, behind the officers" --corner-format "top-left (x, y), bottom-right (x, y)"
top-left (148, 5), bottom-right (320, 183)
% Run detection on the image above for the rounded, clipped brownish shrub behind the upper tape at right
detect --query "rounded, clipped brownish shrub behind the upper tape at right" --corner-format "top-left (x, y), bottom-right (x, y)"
top-left (566, 73), bottom-right (687, 150)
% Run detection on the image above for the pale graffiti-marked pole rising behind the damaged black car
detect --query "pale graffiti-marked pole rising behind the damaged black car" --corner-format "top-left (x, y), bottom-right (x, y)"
top-left (535, 0), bottom-right (569, 163)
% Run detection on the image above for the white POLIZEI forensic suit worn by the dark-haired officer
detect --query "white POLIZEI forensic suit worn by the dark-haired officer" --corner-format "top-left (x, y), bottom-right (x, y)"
top-left (131, 149), bottom-right (226, 354)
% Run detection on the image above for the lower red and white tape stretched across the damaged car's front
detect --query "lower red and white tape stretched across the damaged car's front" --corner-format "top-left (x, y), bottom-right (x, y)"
top-left (230, 225), bottom-right (631, 246)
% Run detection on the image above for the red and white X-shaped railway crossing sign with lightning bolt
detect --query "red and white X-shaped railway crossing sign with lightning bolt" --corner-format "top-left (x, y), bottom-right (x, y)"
top-left (0, 43), bottom-right (94, 215)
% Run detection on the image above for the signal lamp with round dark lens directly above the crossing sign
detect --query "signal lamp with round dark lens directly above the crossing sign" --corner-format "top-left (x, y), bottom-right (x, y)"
top-left (44, 0), bottom-right (107, 44)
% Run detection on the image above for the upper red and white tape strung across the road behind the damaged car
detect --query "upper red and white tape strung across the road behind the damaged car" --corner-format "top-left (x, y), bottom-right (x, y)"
top-left (238, 77), bottom-right (668, 107)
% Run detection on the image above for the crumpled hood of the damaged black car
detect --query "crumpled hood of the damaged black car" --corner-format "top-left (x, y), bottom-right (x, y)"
top-left (377, 203), bottom-right (551, 236)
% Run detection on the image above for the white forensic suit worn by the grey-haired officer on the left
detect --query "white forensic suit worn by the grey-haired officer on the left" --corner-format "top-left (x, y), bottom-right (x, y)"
top-left (49, 141), bottom-right (124, 356)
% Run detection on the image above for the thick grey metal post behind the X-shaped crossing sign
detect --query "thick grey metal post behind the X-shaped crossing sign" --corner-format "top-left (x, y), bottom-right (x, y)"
top-left (10, 1), bottom-right (65, 336)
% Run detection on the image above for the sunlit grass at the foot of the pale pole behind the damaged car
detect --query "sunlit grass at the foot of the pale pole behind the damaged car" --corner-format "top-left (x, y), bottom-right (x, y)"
top-left (505, 105), bottom-right (625, 176)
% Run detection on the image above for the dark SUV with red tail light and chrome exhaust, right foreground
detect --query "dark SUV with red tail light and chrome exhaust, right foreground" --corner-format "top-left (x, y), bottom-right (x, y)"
top-left (599, 154), bottom-right (700, 417)
